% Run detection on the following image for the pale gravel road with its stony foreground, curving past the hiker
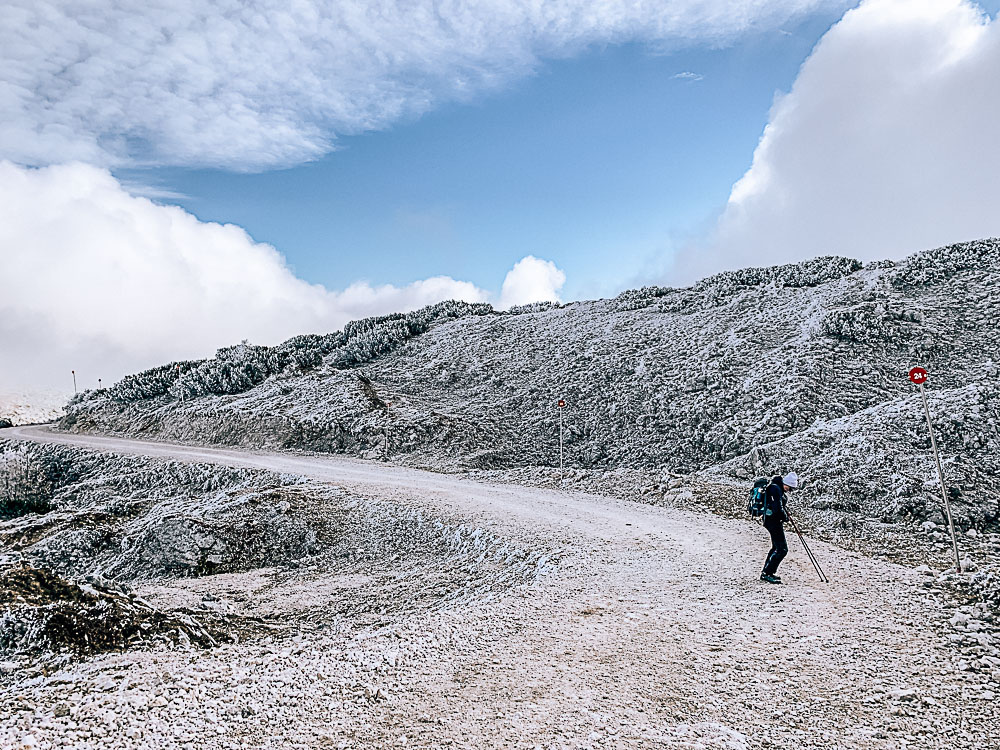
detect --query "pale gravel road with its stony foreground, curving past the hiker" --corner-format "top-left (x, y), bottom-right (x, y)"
top-left (0, 427), bottom-right (1000, 750)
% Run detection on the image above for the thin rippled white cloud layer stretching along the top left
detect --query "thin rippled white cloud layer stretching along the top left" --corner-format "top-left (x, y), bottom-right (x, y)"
top-left (0, 0), bottom-right (845, 169)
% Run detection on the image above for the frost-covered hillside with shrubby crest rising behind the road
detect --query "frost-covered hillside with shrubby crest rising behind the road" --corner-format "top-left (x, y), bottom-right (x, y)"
top-left (61, 240), bottom-right (1000, 525)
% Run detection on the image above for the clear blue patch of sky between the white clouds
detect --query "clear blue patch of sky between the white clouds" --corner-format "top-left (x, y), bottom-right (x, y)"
top-left (118, 6), bottom-right (841, 299)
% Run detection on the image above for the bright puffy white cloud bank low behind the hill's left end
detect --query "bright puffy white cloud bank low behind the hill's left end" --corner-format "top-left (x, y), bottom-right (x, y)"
top-left (0, 162), bottom-right (489, 389)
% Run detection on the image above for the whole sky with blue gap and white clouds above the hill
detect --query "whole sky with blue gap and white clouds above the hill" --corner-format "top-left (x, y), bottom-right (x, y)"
top-left (0, 0), bottom-right (1000, 391)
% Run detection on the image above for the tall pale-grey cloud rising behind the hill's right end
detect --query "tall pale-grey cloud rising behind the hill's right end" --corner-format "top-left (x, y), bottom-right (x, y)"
top-left (675, 0), bottom-right (1000, 281)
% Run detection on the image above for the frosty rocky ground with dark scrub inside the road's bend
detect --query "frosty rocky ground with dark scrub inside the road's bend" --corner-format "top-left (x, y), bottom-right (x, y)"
top-left (0, 438), bottom-right (543, 664)
